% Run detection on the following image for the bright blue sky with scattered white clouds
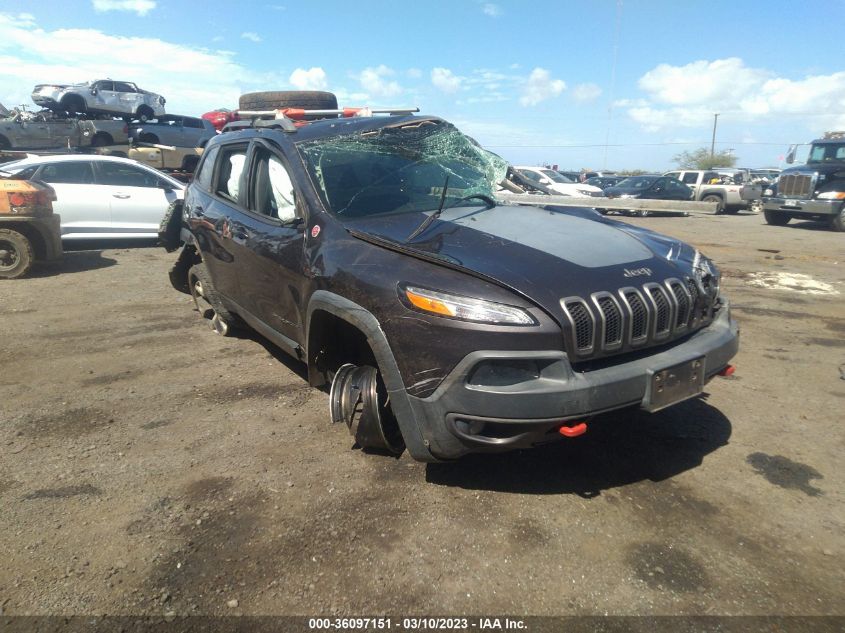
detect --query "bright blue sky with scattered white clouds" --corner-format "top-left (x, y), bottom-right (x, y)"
top-left (0, 0), bottom-right (845, 170)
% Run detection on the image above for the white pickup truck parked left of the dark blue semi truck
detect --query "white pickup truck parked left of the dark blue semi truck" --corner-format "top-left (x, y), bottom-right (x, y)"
top-left (663, 168), bottom-right (763, 213)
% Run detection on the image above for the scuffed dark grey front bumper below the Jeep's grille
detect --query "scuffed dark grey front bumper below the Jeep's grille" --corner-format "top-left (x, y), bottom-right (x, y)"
top-left (409, 303), bottom-right (739, 459)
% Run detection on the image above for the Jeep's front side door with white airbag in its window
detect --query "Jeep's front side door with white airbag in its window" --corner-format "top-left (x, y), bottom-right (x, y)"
top-left (232, 140), bottom-right (305, 343)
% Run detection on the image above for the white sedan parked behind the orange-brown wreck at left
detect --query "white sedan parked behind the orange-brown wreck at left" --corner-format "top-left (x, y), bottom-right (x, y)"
top-left (0, 154), bottom-right (185, 240)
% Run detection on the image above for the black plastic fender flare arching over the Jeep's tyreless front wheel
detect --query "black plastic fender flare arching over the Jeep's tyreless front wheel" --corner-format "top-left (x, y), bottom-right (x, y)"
top-left (305, 290), bottom-right (439, 462)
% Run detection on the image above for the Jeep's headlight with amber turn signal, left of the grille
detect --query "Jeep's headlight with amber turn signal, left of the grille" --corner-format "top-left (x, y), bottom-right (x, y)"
top-left (400, 286), bottom-right (536, 325)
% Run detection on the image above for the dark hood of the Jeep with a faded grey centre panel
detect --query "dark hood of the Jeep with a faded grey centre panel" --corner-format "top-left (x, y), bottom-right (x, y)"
top-left (346, 205), bottom-right (695, 323)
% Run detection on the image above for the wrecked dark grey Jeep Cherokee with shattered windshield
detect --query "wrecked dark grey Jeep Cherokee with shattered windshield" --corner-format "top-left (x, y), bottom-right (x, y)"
top-left (171, 115), bottom-right (738, 461)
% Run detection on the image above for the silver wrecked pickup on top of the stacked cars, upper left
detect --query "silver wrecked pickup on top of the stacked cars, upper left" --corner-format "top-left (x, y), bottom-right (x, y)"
top-left (32, 79), bottom-right (166, 122)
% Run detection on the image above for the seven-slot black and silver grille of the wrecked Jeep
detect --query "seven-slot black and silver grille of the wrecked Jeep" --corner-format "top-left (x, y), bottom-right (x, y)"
top-left (561, 278), bottom-right (713, 358)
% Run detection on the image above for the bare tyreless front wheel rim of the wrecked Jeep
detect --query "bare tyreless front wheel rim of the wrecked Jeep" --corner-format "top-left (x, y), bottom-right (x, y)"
top-left (329, 364), bottom-right (405, 455)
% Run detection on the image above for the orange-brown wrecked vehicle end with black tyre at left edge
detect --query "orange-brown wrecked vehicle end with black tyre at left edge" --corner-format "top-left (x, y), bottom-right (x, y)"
top-left (0, 171), bottom-right (62, 279)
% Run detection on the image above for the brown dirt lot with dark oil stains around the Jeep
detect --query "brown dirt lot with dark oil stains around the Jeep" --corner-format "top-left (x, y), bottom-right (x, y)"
top-left (0, 214), bottom-right (845, 615)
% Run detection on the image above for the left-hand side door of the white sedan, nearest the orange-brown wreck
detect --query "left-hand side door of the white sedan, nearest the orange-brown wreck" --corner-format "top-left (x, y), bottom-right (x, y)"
top-left (33, 160), bottom-right (111, 239)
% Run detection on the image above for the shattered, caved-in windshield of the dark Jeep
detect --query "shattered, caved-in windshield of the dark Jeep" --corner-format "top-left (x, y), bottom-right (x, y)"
top-left (297, 120), bottom-right (508, 217)
